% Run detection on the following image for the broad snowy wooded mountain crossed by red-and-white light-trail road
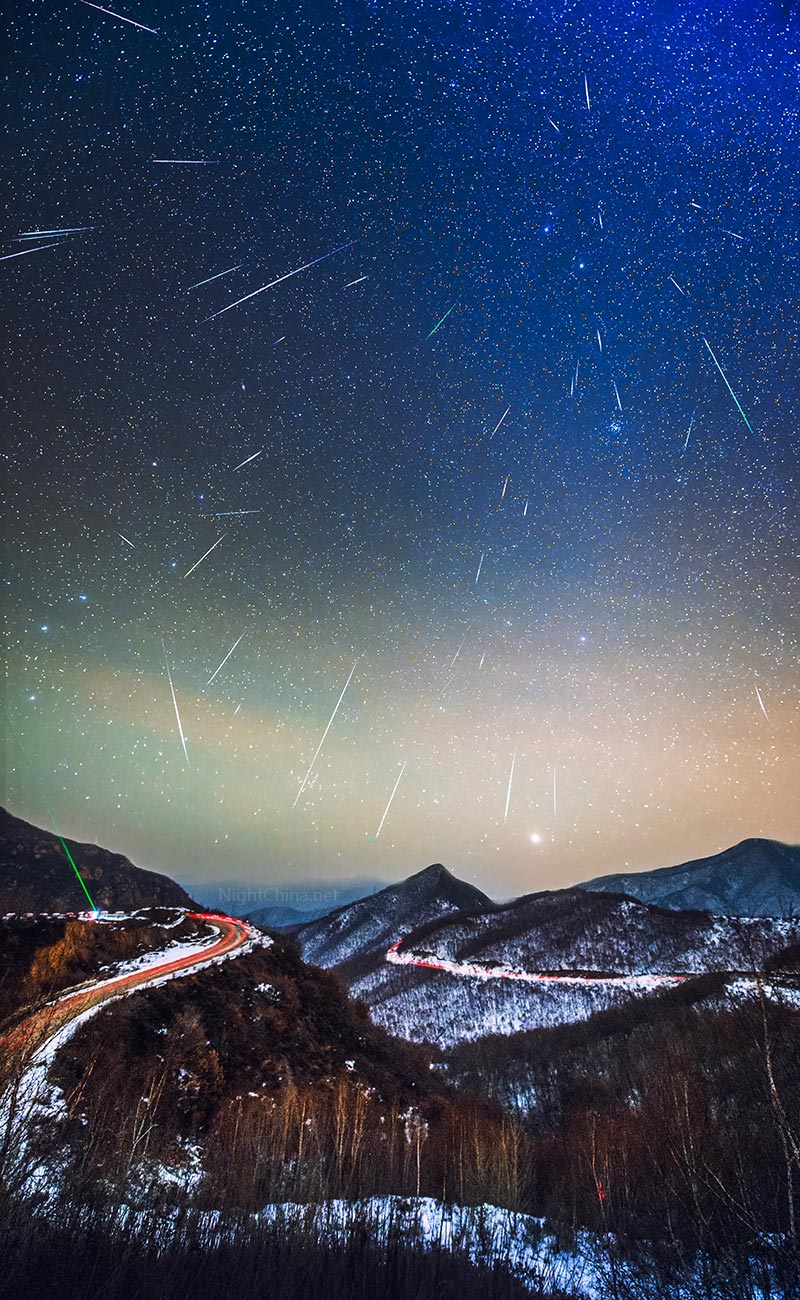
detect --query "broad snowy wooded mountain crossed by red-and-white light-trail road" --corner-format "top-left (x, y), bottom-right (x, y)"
top-left (309, 872), bottom-right (800, 1048)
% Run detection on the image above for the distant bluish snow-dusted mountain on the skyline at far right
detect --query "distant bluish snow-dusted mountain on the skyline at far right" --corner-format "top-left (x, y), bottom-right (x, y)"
top-left (580, 840), bottom-right (800, 917)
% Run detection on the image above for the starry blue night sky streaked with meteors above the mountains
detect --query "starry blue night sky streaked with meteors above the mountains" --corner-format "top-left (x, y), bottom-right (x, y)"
top-left (0, 0), bottom-right (800, 894)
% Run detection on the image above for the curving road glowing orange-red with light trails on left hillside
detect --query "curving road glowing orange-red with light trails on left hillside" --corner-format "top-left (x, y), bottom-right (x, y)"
top-left (0, 913), bottom-right (252, 1061)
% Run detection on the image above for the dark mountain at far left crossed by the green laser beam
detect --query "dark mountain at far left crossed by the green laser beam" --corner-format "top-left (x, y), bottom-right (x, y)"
top-left (0, 809), bottom-right (196, 914)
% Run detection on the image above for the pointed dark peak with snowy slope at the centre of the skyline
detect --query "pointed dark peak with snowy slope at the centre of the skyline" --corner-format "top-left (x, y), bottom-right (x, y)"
top-left (294, 862), bottom-right (493, 967)
